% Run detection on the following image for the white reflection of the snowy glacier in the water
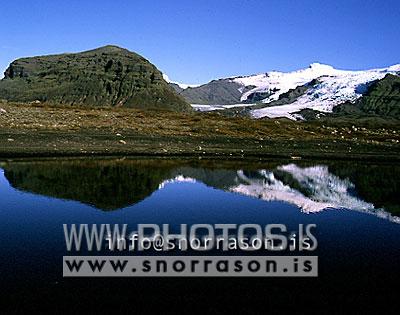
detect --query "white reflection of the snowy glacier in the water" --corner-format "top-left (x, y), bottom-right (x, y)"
top-left (159, 164), bottom-right (400, 223)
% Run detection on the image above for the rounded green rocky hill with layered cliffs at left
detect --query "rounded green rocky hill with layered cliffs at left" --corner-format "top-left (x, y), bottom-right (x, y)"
top-left (0, 46), bottom-right (191, 111)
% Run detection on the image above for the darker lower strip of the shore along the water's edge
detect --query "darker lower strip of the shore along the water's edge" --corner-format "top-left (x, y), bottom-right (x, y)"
top-left (0, 130), bottom-right (400, 161)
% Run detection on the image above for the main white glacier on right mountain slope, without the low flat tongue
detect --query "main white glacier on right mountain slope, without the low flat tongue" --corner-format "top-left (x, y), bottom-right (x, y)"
top-left (250, 64), bottom-right (400, 119)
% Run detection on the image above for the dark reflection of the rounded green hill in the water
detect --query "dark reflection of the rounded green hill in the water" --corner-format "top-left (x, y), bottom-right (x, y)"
top-left (4, 160), bottom-right (170, 210)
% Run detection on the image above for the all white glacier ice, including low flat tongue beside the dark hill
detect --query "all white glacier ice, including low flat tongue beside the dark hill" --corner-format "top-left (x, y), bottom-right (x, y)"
top-left (180, 63), bottom-right (400, 120)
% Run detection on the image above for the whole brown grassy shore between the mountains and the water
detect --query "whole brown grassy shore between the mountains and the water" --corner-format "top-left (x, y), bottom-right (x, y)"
top-left (0, 101), bottom-right (400, 161)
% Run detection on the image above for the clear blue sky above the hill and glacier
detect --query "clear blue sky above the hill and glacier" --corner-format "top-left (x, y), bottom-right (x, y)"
top-left (0, 0), bottom-right (400, 84)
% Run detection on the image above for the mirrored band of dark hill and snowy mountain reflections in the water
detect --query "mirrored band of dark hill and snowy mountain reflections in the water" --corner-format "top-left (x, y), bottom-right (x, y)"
top-left (1, 159), bottom-right (400, 222)
